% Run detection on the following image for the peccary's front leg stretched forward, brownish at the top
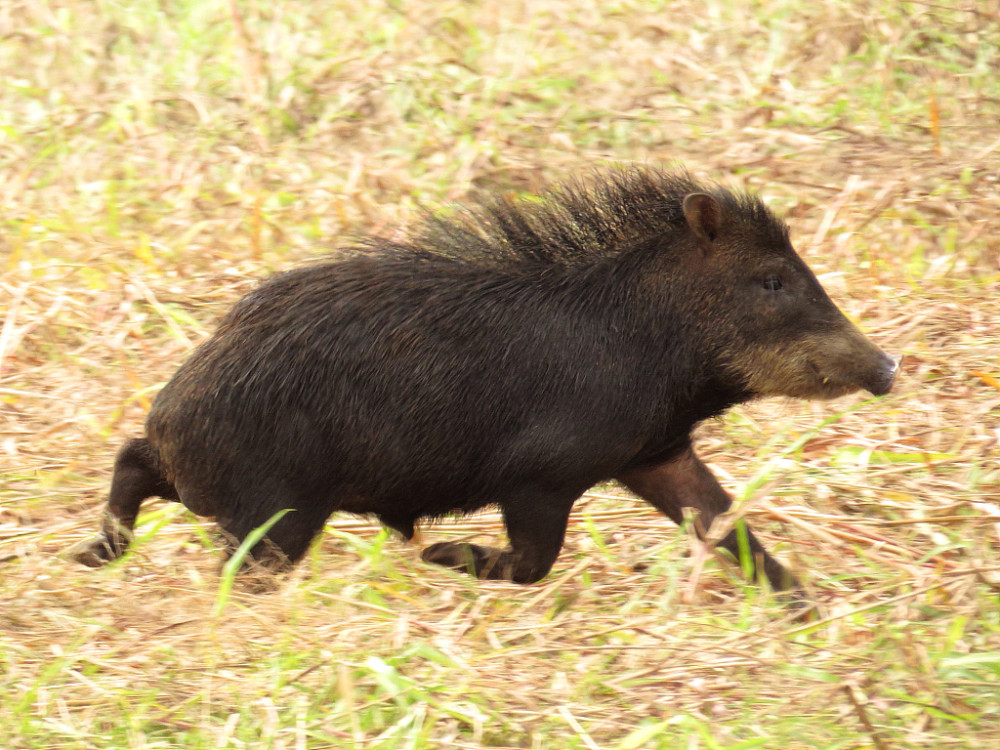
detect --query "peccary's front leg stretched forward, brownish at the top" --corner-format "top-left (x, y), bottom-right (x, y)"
top-left (617, 445), bottom-right (800, 591)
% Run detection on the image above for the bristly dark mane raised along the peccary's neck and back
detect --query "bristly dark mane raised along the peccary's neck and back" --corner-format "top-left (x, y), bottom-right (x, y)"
top-left (361, 167), bottom-right (785, 270)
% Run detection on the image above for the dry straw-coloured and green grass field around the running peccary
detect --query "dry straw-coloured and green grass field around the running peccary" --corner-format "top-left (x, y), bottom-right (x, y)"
top-left (0, 0), bottom-right (1000, 750)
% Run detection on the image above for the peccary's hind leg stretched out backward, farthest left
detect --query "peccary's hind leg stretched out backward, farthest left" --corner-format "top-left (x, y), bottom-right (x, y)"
top-left (73, 438), bottom-right (178, 568)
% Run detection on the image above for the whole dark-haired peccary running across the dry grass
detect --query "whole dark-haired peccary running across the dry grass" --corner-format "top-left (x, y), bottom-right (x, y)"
top-left (70, 168), bottom-right (896, 588)
